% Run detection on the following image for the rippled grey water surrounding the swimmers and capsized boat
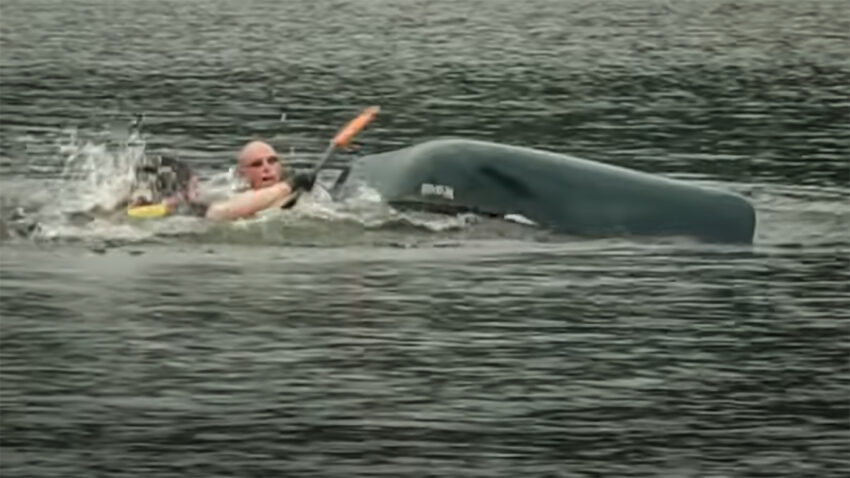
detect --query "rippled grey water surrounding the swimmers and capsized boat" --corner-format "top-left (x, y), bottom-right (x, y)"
top-left (0, 0), bottom-right (850, 477)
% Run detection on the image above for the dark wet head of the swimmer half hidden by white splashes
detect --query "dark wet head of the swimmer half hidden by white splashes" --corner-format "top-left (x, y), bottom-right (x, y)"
top-left (130, 156), bottom-right (193, 204)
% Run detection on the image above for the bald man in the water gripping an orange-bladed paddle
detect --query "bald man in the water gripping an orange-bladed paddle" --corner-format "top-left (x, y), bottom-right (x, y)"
top-left (206, 141), bottom-right (316, 220)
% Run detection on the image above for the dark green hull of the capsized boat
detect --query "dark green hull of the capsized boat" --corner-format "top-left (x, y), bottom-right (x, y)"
top-left (344, 139), bottom-right (755, 243)
